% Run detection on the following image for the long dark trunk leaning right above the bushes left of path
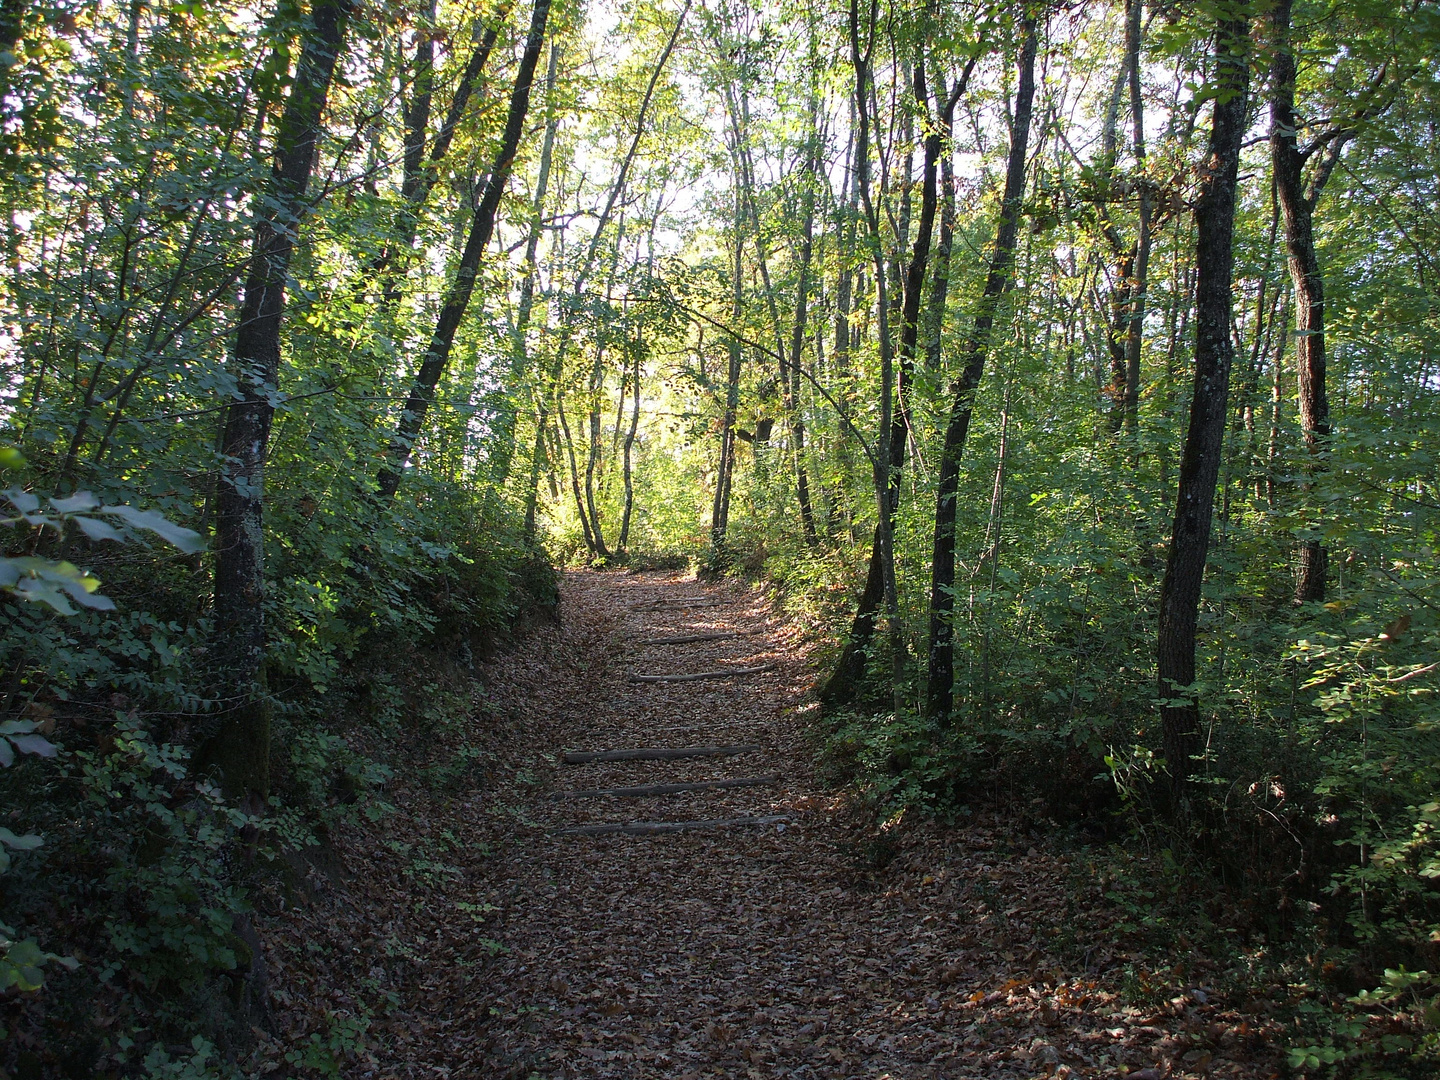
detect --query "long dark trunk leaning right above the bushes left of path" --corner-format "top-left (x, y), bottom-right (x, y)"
top-left (377, 0), bottom-right (550, 500)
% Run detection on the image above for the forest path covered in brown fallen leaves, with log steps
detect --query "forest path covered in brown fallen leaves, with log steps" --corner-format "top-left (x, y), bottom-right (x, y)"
top-left (258, 572), bottom-right (1280, 1080)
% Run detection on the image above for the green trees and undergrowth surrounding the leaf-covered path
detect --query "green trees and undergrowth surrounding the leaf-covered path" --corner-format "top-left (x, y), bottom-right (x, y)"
top-left (0, 0), bottom-right (1440, 1076)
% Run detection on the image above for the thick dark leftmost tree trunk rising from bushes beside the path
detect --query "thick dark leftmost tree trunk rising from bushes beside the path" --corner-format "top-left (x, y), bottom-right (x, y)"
top-left (208, 0), bottom-right (351, 814)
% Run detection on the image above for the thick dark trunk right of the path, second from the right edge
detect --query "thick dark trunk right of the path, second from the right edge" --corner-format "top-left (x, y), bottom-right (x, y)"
top-left (1155, 6), bottom-right (1250, 814)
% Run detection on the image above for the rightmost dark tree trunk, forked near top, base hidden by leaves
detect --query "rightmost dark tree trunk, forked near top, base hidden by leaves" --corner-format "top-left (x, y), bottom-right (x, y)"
top-left (1270, 0), bottom-right (1345, 603)
